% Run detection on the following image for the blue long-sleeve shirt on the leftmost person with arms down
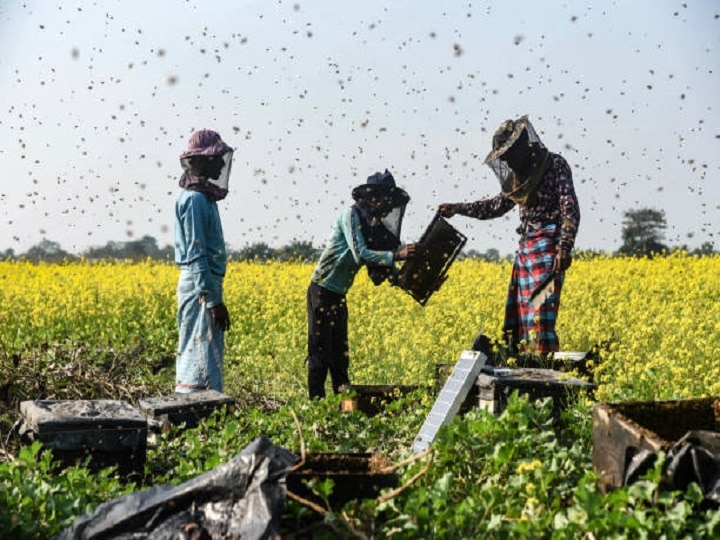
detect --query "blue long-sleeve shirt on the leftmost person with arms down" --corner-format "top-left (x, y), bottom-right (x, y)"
top-left (175, 189), bottom-right (227, 308)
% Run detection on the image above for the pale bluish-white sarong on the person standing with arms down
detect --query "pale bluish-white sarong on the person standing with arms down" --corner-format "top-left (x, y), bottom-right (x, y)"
top-left (175, 270), bottom-right (225, 394)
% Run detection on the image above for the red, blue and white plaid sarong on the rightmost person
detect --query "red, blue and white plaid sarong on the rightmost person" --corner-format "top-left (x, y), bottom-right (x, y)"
top-left (503, 225), bottom-right (565, 353)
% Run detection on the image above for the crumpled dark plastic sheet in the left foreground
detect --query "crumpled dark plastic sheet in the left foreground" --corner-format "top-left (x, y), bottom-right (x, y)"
top-left (54, 437), bottom-right (298, 540)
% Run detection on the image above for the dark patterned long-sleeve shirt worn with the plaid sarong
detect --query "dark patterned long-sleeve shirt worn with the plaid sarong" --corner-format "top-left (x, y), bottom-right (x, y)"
top-left (457, 153), bottom-right (580, 251)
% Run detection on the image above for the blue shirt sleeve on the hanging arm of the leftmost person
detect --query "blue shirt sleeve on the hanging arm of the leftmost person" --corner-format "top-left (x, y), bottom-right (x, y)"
top-left (180, 193), bottom-right (223, 308)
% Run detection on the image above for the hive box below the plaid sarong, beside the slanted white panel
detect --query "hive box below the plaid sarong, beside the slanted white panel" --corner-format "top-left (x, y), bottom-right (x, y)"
top-left (476, 368), bottom-right (595, 419)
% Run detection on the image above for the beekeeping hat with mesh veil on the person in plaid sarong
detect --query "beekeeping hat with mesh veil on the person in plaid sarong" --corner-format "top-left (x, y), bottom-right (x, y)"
top-left (485, 115), bottom-right (547, 194)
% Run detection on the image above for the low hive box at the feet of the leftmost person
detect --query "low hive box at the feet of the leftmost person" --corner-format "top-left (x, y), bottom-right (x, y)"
top-left (138, 390), bottom-right (235, 427)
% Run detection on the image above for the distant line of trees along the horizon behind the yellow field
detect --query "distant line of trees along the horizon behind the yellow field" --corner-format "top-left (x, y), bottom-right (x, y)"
top-left (0, 208), bottom-right (717, 262)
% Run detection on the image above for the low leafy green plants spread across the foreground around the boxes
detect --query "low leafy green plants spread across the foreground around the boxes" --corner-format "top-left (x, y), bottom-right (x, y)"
top-left (0, 389), bottom-right (720, 539)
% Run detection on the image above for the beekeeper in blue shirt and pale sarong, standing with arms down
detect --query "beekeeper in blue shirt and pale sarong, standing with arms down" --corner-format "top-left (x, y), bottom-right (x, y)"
top-left (175, 130), bottom-right (233, 393)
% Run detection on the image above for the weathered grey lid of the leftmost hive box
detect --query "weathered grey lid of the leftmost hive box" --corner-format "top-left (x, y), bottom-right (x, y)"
top-left (20, 399), bottom-right (147, 434)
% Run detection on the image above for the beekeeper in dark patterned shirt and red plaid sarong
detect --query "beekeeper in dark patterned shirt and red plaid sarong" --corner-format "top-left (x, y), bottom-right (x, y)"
top-left (438, 116), bottom-right (580, 353)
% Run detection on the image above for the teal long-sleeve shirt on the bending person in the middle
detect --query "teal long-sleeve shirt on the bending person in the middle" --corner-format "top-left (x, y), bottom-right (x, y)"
top-left (311, 207), bottom-right (395, 295)
